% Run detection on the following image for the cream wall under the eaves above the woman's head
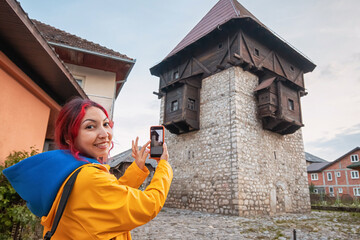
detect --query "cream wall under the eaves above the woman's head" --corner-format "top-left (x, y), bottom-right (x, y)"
top-left (66, 63), bottom-right (116, 116)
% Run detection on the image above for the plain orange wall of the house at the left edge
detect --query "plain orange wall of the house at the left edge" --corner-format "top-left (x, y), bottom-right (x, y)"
top-left (0, 52), bottom-right (51, 164)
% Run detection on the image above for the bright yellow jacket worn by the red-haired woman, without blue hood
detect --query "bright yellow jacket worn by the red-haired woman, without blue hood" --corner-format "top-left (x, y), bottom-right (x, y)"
top-left (41, 160), bottom-right (173, 240)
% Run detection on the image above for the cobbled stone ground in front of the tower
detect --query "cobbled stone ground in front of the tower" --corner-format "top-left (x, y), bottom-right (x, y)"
top-left (131, 208), bottom-right (360, 240)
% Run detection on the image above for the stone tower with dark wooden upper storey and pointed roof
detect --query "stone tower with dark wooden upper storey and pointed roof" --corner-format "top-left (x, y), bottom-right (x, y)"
top-left (150, 0), bottom-right (315, 216)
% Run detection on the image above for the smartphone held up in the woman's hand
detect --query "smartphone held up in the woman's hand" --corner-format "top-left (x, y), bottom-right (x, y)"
top-left (150, 126), bottom-right (165, 159)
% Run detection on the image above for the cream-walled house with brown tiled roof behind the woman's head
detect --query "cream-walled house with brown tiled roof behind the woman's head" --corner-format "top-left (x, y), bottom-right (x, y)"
top-left (32, 20), bottom-right (135, 118)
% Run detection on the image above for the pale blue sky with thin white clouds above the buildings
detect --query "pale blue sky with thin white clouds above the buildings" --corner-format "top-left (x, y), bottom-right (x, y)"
top-left (18, 0), bottom-right (360, 161)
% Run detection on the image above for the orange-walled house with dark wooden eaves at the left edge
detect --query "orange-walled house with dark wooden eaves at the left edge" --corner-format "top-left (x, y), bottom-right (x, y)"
top-left (0, 0), bottom-right (87, 164)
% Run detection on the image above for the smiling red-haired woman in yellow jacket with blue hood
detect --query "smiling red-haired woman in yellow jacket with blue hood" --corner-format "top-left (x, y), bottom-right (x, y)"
top-left (4, 98), bottom-right (173, 240)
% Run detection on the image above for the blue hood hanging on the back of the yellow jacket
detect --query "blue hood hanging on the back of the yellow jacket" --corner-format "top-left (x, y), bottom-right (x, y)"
top-left (3, 150), bottom-right (100, 217)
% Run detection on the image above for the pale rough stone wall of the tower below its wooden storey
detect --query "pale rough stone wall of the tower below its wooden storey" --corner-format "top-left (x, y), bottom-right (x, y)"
top-left (160, 67), bottom-right (310, 216)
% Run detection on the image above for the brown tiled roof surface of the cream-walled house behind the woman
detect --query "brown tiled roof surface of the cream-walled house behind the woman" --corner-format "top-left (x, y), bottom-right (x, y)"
top-left (32, 19), bottom-right (134, 60)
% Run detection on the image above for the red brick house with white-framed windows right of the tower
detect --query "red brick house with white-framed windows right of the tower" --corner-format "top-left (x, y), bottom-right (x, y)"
top-left (307, 147), bottom-right (360, 197)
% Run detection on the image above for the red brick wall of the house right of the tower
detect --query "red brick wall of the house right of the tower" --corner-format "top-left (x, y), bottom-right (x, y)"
top-left (308, 151), bottom-right (360, 197)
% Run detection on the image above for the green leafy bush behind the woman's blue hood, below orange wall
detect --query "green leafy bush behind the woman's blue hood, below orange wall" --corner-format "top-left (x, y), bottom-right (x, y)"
top-left (0, 147), bottom-right (41, 240)
